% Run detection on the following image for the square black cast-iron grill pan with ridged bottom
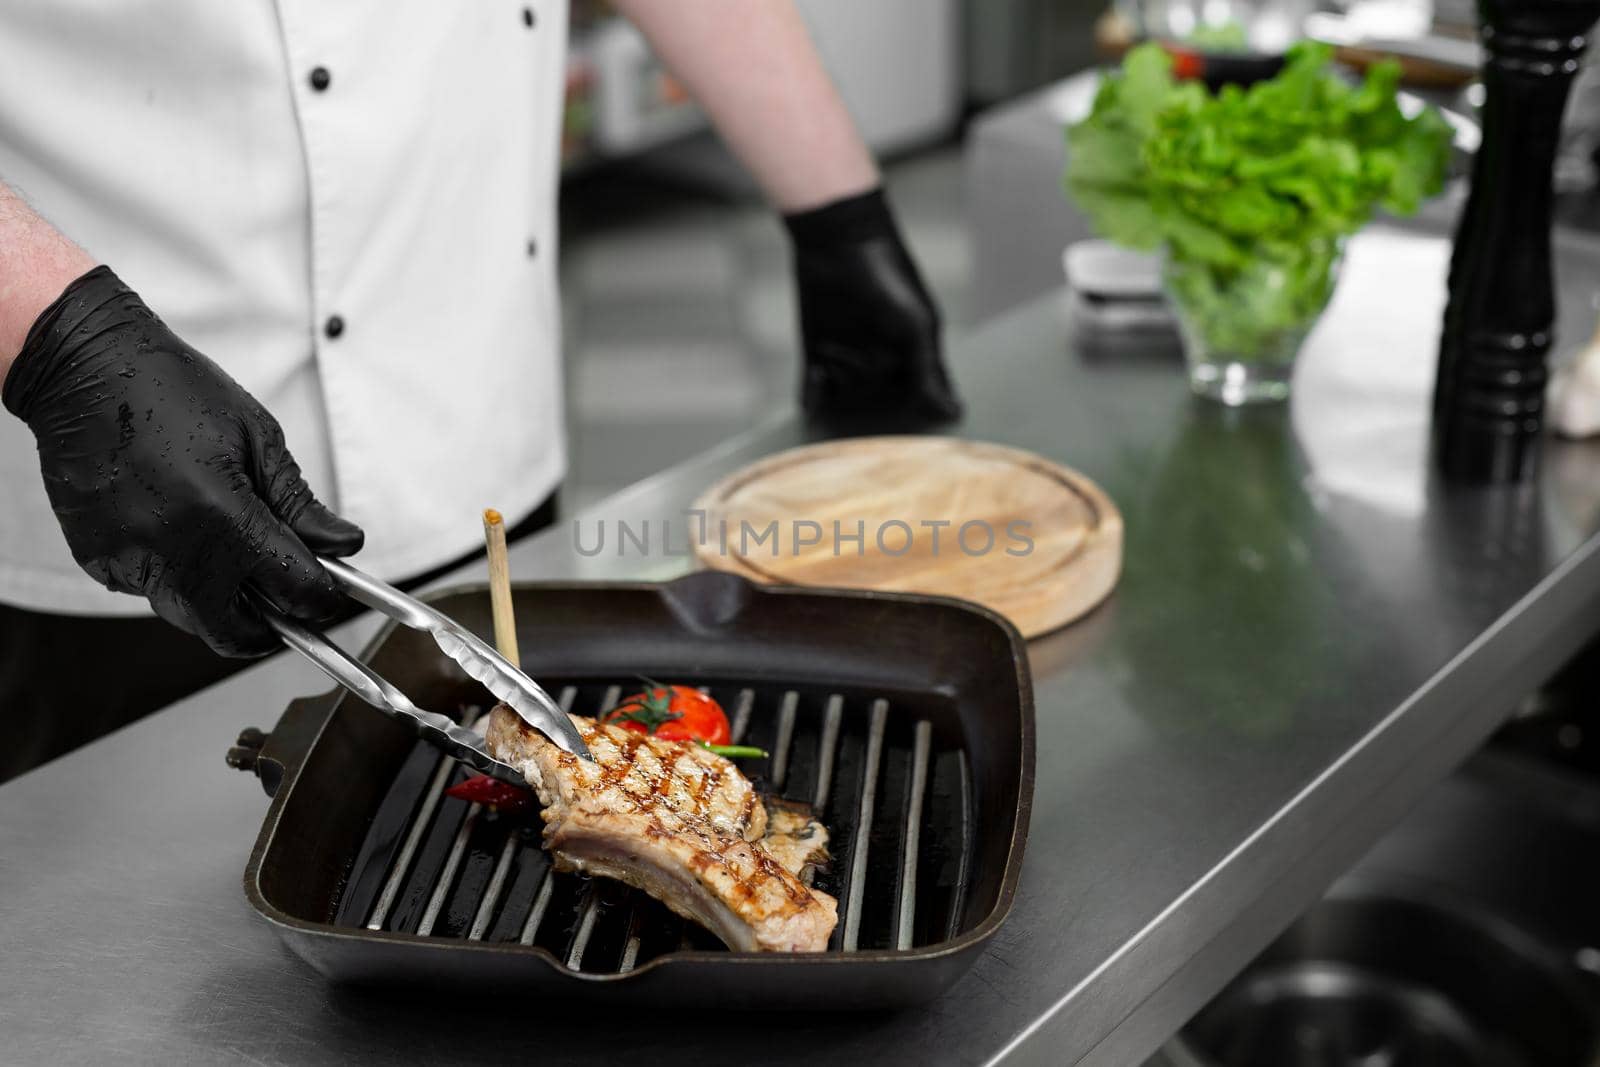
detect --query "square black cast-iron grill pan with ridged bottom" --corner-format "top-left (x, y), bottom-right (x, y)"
top-left (245, 573), bottom-right (1034, 1008)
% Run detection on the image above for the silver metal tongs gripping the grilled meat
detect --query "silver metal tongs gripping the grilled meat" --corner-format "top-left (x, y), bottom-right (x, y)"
top-left (256, 558), bottom-right (594, 787)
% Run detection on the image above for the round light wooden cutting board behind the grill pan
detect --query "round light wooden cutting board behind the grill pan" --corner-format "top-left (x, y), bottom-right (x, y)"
top-left (691, 437), bottom-right (1122, 637)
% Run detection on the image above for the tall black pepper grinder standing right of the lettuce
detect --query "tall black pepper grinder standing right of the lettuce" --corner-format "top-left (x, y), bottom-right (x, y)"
top-left (1434, 0), bottom-right (1600, 483)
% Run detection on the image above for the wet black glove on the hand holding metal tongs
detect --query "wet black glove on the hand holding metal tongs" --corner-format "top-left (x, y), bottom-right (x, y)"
top-left (3, 267), bottom-right (363, 656)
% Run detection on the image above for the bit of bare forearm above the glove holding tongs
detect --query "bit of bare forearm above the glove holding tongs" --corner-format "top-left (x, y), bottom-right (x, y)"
top-left (0, 182), bottom-right (96, 384)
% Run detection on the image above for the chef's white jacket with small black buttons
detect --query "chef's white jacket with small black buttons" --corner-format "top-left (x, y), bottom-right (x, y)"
top-left (0, 0), bottom-right (566, 614)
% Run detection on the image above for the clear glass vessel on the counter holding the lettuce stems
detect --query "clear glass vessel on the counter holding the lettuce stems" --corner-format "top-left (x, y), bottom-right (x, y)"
top-left (1163, 240), bottom-right (1342, 406)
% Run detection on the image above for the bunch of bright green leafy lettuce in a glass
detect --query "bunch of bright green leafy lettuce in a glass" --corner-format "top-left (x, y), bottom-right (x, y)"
top-left (1066, 43), bottom-right (1451, 272)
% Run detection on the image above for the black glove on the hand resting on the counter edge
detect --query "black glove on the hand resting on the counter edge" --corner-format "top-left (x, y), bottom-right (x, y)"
top-left (784, 189), bottom-right (962, 422)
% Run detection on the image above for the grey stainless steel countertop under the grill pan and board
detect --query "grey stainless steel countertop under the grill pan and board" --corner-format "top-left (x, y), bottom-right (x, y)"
top-left (9, 230), bottom-right (1600, 1067)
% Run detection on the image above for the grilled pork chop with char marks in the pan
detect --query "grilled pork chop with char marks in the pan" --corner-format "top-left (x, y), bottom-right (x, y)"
top-left (485, 705), bottom-right (838, 952)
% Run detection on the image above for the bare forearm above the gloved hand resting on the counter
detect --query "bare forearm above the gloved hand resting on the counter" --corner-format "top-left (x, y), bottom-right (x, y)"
top-left (616, 0), bottom-right (878, 213)
